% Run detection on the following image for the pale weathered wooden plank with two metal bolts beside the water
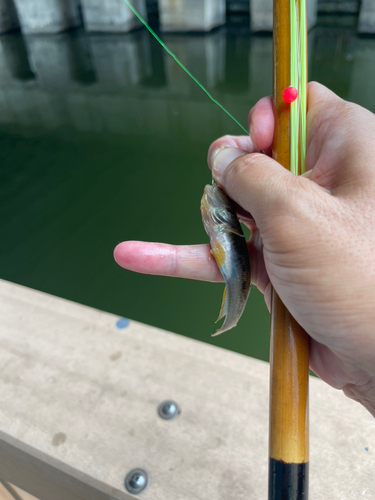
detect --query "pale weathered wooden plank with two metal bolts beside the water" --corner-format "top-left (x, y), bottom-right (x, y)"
top-left (0, 281), bottom-right (375, 500)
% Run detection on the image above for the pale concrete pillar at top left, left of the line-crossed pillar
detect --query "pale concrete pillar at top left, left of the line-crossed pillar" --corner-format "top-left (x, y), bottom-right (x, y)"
top-left (15, 0), bottom-right (81, 33)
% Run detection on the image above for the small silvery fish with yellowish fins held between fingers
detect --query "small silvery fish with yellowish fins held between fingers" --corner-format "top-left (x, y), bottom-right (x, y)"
top-left (201, 181), bottom-right (251, 336)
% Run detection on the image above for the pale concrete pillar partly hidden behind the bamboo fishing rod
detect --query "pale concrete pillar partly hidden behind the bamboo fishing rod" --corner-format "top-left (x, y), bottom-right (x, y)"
top-left (250, 0), bottom-right (318, 31)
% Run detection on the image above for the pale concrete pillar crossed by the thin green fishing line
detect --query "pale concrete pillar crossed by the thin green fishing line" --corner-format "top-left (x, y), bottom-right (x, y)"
top-left (81, 0), bottom-right (147, 32)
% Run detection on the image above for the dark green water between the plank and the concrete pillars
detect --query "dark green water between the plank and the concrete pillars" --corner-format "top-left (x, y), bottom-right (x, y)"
top-left (0, 18), bottom-right (375, 359)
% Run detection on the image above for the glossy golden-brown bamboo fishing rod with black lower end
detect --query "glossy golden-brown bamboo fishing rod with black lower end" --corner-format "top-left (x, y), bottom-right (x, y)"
top-left (268, 0), bottom-right (309, 500)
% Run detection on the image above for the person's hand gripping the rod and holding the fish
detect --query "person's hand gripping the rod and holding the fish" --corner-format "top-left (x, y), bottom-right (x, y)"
top-left (115, 83), bottom-right (375, 416)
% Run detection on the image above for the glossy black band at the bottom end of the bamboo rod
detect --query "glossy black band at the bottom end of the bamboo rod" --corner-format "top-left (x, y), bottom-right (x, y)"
top-left (268, 458), bottom-right (309, 500)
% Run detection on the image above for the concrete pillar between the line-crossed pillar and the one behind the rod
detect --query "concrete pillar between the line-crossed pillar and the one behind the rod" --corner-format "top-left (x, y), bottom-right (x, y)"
top-left (159, 0), bottom-right (225, 31)
